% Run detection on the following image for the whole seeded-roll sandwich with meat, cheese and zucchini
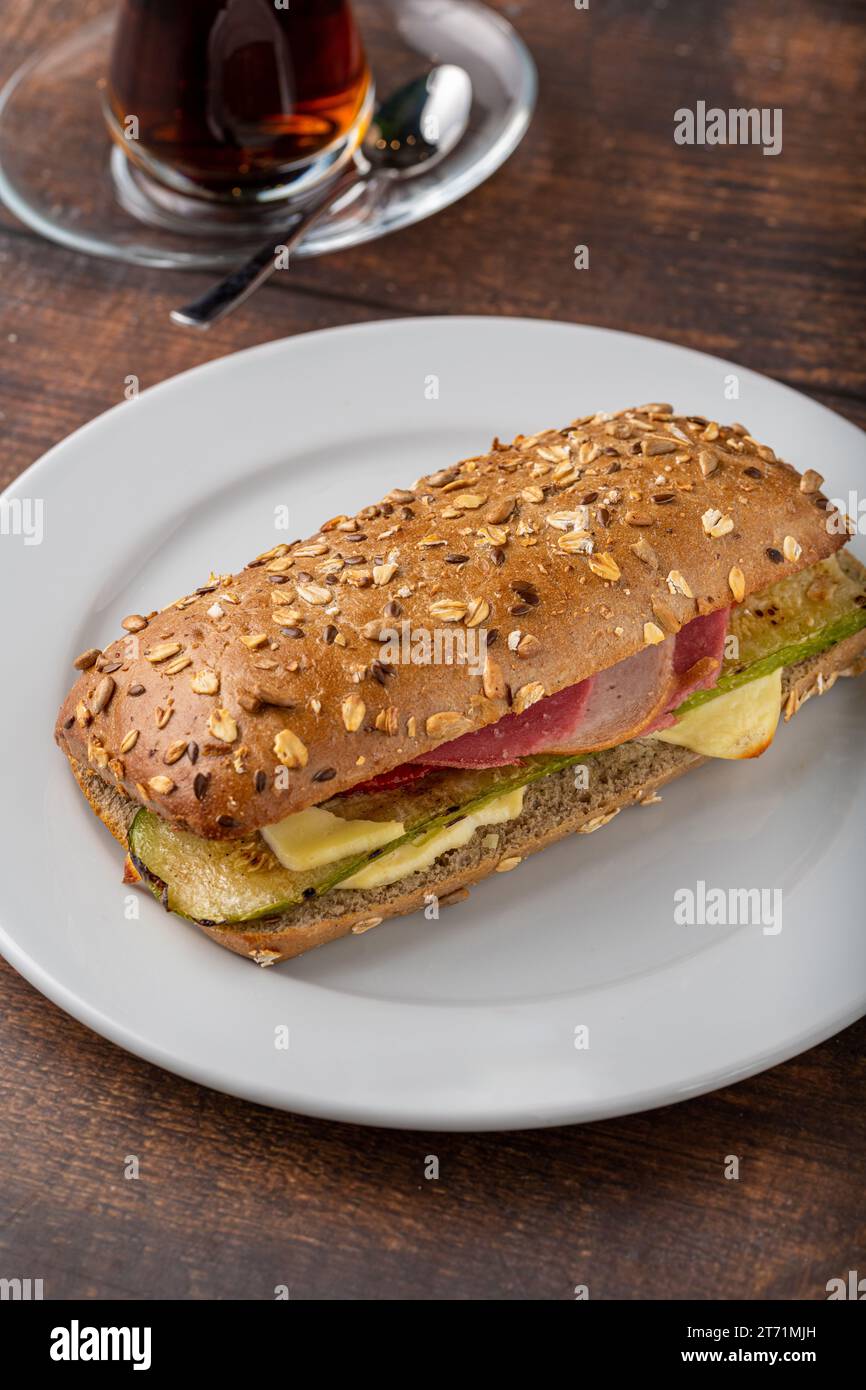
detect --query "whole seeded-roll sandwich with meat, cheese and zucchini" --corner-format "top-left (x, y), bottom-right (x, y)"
top-left (56, 404), bottom-right (866, 965)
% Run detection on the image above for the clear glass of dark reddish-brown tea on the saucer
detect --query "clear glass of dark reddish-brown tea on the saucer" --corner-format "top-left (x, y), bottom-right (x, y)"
top-left (104, 0), bottom-right (374, 209)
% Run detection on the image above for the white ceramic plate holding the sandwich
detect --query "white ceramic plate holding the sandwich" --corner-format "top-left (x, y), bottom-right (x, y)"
top-left (0, 318), bottom-right (866, 1129)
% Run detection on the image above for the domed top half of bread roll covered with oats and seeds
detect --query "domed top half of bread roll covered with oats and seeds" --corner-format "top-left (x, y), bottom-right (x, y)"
top-left (56, 404), bottom-right (845, 838)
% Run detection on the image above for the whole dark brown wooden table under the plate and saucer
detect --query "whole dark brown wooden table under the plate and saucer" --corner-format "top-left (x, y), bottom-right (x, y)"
top-left (0, 0), bottom-right (866, 1298)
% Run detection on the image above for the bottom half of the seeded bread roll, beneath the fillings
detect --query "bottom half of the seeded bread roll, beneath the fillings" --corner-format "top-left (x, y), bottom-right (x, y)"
top-left (66, 630), bottom-right (866, 966)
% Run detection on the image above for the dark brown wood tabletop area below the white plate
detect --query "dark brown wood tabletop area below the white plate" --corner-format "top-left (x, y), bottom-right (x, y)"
top-left (0, 967), bottom-right (866, 1298)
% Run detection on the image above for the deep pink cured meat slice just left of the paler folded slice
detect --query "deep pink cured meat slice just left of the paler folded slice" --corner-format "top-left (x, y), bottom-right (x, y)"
top-left (416, 667), bottom-right (594, 767)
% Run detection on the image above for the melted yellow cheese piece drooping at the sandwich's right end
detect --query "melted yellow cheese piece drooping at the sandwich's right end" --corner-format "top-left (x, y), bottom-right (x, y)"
top-left (652, 669), bottom-right (781, 758)
